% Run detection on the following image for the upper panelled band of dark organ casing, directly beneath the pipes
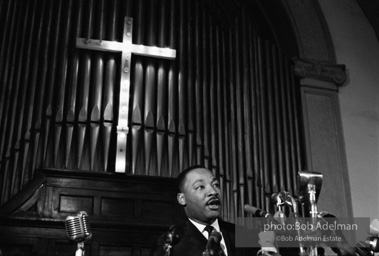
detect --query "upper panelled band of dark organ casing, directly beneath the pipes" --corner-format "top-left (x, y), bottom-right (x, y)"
top-left (0, 169), bottom-right (182, 226)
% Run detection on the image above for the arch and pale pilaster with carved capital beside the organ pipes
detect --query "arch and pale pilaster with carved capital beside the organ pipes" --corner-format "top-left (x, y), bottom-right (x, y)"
top-left (257, 0), bottom-right (354, 224)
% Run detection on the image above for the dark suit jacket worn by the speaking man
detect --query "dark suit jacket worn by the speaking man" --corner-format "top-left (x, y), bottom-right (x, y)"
top-left (150, 220), bottom-right (260, 256)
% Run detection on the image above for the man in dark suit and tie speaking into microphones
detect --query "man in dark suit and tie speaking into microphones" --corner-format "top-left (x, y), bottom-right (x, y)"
top-left (151, 166), bottom-right (276, 256)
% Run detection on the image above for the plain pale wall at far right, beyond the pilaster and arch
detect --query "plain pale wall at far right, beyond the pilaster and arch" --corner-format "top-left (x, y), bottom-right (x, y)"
top-left (319, 0), bottom-right (379, 219)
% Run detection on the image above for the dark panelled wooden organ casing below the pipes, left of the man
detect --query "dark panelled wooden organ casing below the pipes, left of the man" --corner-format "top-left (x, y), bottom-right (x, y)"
top-left (0, 169), bottom-right (184, 256)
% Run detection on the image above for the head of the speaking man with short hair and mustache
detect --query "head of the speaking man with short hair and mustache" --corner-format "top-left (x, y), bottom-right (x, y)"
top-left (178, 168), bottom-right (221, 224)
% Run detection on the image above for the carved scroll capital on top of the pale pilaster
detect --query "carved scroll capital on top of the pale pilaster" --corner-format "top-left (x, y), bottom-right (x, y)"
top-left (293, 58), bottom-right (347, 86)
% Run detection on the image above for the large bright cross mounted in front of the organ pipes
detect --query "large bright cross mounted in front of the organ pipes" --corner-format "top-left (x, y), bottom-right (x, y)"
top-left (76, 17), bottom-right (176, 172)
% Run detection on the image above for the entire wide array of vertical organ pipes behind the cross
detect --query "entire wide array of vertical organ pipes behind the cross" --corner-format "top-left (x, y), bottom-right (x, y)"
top-left (0, 0), bottom-right (308, 210)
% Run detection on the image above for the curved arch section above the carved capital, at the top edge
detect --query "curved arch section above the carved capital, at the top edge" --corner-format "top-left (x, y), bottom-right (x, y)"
top-left (256, 0), bottom-right (336, 64)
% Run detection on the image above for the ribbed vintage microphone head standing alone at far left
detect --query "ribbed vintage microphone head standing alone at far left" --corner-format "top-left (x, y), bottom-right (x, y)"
top-left (65, 211), bottom-right (92, 243)
